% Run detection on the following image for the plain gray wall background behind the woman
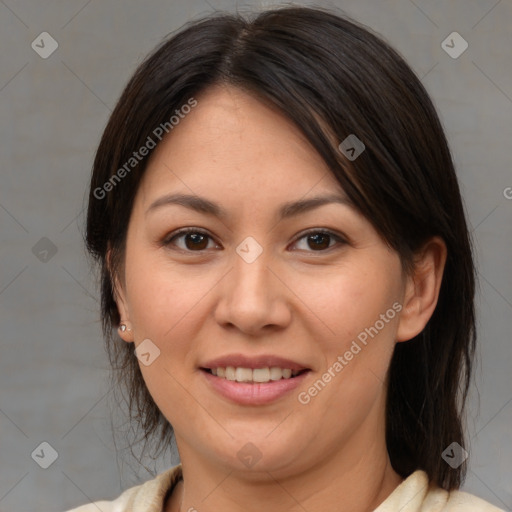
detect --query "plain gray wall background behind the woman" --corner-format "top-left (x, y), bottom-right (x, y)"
top-left (0, 0), bottom-right (512, 512)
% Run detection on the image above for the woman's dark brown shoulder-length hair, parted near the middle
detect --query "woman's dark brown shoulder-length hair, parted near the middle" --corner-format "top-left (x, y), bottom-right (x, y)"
top-left (85, 6), bottom-right (476, 490)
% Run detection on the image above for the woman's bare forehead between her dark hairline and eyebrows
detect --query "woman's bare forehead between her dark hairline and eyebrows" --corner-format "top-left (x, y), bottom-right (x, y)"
top-left (135, 85), bottom-right (342, 209)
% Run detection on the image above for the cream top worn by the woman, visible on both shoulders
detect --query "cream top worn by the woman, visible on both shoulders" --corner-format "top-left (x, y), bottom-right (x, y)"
top-left (67, 464), bottom-right (504, 512)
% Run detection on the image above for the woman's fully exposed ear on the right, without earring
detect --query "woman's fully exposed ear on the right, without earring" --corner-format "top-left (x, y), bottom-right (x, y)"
top-left (396, 236), bottom-right (447, 341)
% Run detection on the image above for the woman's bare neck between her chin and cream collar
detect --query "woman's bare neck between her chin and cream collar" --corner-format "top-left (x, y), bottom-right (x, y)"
top-left (166, 420), bottom-right (402, 512)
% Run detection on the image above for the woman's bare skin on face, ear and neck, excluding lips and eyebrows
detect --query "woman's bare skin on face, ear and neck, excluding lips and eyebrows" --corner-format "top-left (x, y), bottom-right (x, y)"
top-left (115, 86), bottom-right (446, 512)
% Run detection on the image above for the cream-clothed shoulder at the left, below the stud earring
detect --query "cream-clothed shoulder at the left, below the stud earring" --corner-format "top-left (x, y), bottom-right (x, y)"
top-left (67, 464), bottom-right (182, 512)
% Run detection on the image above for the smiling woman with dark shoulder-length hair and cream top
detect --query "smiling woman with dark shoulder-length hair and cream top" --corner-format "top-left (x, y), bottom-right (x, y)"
top-left (68, 7), bottom-right (504, 512)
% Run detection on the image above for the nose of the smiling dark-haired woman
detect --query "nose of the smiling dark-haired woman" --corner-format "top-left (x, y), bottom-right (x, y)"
top-left (215, 250), bottom-right (293, 335)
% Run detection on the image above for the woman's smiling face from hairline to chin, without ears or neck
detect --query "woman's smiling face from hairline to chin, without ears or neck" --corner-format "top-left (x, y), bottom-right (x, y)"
top-left (118, 87), bottom-right (412, 475)
